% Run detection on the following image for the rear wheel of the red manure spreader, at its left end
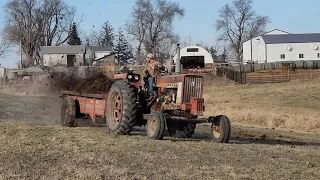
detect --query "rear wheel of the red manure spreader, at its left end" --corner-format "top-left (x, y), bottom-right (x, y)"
top-left (61, 97), bottom-right (76, 127)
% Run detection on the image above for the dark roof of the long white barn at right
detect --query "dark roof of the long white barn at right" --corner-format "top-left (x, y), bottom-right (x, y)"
top-left (262, 33), bottom-right (320, 44)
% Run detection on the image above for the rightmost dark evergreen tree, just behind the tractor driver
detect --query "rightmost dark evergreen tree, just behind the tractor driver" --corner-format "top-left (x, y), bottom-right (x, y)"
top-left (114, 27), bottom-right (133, 66)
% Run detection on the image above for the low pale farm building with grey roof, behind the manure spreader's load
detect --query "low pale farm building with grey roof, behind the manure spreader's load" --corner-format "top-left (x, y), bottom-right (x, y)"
top-left (41, 45), bottom-right (112, 67)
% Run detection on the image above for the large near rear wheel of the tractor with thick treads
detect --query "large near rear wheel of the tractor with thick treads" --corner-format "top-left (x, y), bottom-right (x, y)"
top-left (105, 80), bottom-right (137, 134)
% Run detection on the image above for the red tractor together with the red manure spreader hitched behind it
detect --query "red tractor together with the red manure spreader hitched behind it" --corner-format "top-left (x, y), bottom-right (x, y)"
top-left (61, 65), bottom-right (231, 143)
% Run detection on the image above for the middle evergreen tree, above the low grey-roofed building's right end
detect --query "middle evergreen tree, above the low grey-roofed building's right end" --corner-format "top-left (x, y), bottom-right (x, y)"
top-left (99, 21), bottom-right (114, 47)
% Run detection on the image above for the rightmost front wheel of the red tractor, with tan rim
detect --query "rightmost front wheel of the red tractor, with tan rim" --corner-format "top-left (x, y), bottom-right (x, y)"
top-left (211, 115), bottom-right (231, 143)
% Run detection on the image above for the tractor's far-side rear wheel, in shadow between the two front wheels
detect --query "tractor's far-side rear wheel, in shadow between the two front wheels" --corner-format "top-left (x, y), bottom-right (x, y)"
top-left (167, 122), bottom-right (197, 138)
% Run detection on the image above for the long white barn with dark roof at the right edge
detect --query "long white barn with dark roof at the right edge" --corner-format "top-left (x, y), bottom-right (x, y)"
top-left (243, 29), bottom-right (320, 63)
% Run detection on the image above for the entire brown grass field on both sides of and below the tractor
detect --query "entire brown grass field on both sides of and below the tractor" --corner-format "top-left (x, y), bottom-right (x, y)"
top-left (0, 76), bottom-right (320, 180)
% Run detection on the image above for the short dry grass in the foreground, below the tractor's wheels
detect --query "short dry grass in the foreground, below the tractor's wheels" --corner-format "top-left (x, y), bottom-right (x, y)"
top-left (0, 124), bottom-right (320, 180)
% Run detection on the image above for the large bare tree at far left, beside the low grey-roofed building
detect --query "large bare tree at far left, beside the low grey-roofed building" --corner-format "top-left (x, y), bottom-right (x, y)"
top-left (5, 0), bottom-right (75, 66)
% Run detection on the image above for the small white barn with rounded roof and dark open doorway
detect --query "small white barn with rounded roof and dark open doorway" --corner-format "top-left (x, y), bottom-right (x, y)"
top-left (173, 46), bottom-right (213, 68)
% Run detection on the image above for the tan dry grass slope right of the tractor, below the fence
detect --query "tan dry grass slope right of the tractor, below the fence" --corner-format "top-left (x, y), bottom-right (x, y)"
top-left (204, 81), bottom-right (320, 132)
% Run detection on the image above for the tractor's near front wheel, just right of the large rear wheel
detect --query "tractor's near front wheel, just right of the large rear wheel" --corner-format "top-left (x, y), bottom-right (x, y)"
top-left (147, 111), bottom-right (166, 140)
